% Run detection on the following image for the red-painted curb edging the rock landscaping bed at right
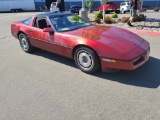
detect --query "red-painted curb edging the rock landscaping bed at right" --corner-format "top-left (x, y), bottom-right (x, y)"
top-left (129, 29), bottom-right (160, 36)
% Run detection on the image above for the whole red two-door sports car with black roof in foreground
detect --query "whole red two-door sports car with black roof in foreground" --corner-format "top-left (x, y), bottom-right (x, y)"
top-left (11, 13), bottom-right (150, 73)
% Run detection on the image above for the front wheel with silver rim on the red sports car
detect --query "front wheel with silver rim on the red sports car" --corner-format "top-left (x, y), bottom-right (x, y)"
top-left (74, 47), bottom-right (100, 74)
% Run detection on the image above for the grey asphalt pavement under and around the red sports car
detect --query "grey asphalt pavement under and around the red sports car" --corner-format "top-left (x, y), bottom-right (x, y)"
top-left (0, 12), bottom-right (160, 120)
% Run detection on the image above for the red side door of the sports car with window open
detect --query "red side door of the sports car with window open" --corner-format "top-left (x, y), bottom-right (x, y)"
top-left (29, 17), bottom-right (61, 54)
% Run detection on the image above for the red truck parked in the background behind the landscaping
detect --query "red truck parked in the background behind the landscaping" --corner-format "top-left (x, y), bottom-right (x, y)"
top-left (99, 2), bottom-right (120, 14)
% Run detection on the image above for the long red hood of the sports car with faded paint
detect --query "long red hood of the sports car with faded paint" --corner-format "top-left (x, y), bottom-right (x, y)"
top-left (65, 25), bottom-right (144, 55)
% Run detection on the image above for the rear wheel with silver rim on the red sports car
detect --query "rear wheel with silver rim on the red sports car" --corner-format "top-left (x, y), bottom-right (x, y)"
top-left (18, 33), bottom-right (33, 53)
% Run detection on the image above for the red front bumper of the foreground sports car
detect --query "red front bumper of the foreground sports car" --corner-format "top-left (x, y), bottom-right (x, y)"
top-left (100, 51), bottom-right (150, 71)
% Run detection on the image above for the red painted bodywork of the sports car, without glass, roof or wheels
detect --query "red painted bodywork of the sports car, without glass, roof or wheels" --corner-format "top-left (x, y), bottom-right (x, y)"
top-left (11, 13), bottom-right (150, 70)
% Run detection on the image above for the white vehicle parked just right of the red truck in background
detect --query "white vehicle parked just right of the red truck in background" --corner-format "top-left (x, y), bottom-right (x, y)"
top-left (120, 2), bottom-right (131, 13)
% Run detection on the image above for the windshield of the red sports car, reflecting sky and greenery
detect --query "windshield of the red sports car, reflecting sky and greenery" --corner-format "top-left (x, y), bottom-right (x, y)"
top-left (50, 15), bottom-right (91, 32)
